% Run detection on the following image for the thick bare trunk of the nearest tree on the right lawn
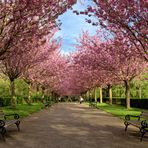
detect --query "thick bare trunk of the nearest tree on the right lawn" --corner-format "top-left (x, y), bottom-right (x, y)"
top-left (124, 80), bottom-right (130, 109)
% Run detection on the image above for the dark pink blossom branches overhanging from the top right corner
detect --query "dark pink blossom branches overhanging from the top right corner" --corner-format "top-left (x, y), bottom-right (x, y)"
top-left (82, 0), bottom-right (148, 61)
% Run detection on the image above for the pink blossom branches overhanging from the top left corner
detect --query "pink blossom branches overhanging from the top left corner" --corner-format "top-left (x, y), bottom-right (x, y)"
top-left (0, 0), bottom-right (76, 59)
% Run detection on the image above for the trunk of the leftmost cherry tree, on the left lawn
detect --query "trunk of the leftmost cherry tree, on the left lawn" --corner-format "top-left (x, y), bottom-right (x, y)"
top-left (10, 80), bottom-right (17, 108)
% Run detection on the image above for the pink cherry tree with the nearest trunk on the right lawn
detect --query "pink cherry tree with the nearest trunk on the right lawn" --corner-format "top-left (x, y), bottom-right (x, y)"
top-left (101, 40), bottom-right (147, 109)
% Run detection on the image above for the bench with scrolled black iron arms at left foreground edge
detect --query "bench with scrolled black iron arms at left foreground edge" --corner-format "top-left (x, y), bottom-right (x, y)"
top-left (0, 110), bottom-right (20, 141)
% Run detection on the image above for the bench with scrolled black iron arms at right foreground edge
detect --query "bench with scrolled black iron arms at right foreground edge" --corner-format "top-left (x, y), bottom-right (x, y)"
top-left (124, 111), bottom-right (148, 141)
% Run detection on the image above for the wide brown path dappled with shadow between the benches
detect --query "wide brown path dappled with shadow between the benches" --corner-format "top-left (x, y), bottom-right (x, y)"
top-left (0, 103), bottom-right (148, 148)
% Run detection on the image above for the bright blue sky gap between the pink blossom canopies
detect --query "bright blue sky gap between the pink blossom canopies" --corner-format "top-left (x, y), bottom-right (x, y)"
top-left (55, 0), bottom-right (98, 54)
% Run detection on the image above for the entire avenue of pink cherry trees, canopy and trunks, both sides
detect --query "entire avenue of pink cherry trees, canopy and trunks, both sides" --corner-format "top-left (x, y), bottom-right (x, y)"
top-left (0, 0), bottom-right (148, 109)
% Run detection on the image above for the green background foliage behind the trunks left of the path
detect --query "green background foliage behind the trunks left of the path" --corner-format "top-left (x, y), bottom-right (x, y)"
top-left (0, 77), bottom-right (46, 106)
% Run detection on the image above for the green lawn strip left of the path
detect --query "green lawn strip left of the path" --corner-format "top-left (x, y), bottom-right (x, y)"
top-left (2, 103), bottom-right (44, 118)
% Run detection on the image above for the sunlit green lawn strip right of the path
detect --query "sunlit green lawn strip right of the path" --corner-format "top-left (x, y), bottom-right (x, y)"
top-left (97, 103), bottom-right (147, 119)
